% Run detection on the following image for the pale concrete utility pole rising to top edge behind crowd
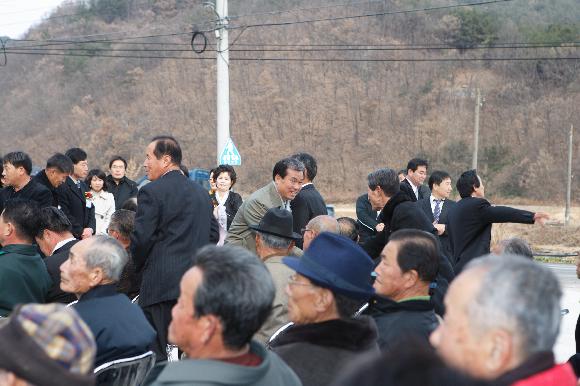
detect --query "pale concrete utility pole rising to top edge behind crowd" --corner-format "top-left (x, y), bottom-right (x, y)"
top-left (215, 0), bottom-right (230, 165)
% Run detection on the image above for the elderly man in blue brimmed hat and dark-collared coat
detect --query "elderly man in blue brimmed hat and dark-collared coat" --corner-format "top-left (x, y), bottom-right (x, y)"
top-left (270, 232), bottom-right (379, 386)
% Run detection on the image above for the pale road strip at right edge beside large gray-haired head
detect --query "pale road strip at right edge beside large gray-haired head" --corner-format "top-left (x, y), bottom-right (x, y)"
top-left (545, 264), bottom-right (580, 362)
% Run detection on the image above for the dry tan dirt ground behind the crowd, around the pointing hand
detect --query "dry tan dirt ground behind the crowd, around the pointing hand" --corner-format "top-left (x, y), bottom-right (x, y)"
top-left (334, 204), bottom-right (580, 253)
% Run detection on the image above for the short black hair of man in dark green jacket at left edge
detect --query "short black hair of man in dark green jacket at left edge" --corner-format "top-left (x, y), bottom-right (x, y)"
top-left (2, 198), bottom-right (40, 243)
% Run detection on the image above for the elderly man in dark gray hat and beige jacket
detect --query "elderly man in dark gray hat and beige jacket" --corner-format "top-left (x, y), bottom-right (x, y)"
top-left (250, 208), bottom-right (301, 344)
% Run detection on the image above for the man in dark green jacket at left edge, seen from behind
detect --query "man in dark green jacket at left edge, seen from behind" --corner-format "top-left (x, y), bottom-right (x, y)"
top-left (0, 199), bottom-right (52, 316)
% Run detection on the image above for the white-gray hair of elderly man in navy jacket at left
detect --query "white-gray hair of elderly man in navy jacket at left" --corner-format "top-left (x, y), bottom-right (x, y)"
top-left (83, 235), bottom-right (129, 282)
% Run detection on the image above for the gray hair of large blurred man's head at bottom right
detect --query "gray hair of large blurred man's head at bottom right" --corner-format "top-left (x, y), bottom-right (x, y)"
top-left (466, 255), bottom-right (562, 360)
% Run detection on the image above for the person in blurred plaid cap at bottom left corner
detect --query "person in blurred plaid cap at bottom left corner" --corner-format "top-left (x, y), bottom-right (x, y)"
top-left (0, 304), bottom-right (96, 386)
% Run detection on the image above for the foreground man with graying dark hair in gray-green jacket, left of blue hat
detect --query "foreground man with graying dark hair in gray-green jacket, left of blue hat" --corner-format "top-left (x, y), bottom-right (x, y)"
top-left (145, 245), bottom-right (302, 386)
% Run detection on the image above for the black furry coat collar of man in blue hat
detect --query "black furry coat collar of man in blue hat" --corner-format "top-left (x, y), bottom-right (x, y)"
top-left (270, 316), bottom-right (378, 351)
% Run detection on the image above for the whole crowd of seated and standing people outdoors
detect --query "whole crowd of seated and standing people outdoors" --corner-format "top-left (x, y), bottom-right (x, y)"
top-left (0, 136), bottom-right (580, 386)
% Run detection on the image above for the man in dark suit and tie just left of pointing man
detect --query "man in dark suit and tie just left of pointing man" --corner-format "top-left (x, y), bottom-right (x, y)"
top-left (417, 170), bottom-right (455, 259)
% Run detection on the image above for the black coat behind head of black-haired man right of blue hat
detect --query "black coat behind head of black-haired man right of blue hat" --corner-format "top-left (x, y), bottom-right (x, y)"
top-left (363, 191), bottom-right (455, 315)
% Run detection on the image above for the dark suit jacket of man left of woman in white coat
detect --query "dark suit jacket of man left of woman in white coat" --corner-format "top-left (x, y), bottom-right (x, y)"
top-left (56, 177), bottom-right (97, 239)
